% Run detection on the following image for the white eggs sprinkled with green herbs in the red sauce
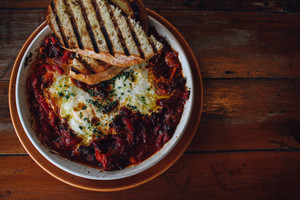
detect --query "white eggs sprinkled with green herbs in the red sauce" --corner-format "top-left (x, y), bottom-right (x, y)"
top-left (47, 64), bottom-right (162, 145)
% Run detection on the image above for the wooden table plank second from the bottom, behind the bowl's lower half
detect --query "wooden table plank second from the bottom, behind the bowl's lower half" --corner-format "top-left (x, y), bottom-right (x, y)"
top-left (0, 79), bottom-right (300, 153)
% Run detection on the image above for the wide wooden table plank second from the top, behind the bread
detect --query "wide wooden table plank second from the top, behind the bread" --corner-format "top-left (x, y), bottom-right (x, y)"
top-left (0, 10), bottom-right (300, 80)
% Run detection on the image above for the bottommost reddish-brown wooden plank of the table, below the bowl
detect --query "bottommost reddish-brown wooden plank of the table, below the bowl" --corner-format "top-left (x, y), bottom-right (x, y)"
top-left (0, 151), bottom-right (300, 200)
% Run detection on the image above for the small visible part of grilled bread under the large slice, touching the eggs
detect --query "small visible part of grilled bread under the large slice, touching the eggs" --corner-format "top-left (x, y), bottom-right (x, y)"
top-left (69, 55), bottom-right (126, 85)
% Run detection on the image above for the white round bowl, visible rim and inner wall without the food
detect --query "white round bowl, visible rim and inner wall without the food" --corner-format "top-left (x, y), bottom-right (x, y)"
top-left (15, 16), bottom-right (194, 180)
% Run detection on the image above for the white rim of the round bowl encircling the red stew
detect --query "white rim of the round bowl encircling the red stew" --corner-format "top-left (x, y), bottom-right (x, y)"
top-left (15, 16), bottom-right (194, 180)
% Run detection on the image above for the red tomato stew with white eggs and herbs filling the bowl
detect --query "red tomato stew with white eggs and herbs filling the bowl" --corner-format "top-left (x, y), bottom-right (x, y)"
top-left (27, 30), bottom-right (190, 171)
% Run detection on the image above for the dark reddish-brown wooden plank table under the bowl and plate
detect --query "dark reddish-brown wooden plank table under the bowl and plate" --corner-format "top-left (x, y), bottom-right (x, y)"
top-left (0, 0), bottom-right (300, 200)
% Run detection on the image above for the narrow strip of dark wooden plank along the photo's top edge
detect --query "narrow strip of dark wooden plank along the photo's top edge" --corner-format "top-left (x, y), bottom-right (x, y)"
top-left (0, 0), bottom-right (300, 12)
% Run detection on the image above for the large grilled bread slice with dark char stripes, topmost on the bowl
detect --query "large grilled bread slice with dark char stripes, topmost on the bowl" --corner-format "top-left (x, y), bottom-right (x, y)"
top-left (47, 0), bottom-right (162, 67)
